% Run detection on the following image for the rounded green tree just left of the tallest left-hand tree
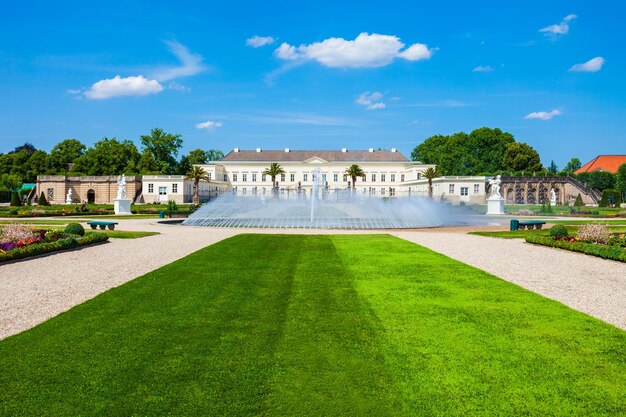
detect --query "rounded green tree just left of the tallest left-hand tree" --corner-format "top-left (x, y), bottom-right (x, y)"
top-left (72, 138), bottom-right (141, 175)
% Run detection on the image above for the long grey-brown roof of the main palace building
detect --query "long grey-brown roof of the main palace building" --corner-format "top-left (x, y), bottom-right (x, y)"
top-left (222, 148), bottom-right (410, 162)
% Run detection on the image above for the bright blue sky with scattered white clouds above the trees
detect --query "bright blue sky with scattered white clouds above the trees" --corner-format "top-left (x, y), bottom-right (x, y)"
top-left (0, 1), bottom-right (626, 166)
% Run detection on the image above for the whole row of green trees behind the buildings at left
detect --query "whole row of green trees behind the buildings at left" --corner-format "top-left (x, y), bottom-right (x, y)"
top-left (0, 128), bottom-right (224, 190)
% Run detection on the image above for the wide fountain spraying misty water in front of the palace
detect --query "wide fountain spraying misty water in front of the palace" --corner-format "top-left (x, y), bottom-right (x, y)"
top-left (183, 168), bottom-right (467, 229)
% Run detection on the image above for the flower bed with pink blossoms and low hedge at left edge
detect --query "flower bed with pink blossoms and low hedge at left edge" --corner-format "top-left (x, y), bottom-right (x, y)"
top-left (0, 224), bottom-right (109, 263)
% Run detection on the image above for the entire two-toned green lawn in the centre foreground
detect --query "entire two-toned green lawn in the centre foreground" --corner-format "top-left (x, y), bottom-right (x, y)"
top-left (0, 235), bottom-right (626, 416)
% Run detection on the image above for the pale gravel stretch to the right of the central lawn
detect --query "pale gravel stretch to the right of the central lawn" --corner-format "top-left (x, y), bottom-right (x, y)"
top-left (393, 231), bottom-right (626, 330)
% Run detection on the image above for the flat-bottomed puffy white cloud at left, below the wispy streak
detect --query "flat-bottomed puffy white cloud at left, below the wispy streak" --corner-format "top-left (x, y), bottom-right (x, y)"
top-left (85, 75), bottom-right (163, 100)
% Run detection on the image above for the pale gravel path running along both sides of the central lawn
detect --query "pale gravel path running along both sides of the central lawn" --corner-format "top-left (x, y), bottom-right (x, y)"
top-left (0, 219), bottom-right (626, 339)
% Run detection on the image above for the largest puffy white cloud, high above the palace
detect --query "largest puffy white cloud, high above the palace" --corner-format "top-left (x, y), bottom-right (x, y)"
top-left (274, 32), bottom-right (434, 68)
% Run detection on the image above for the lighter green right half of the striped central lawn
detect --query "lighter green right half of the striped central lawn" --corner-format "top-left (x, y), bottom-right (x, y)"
top-left (333, 236), bottom-right (626, 416)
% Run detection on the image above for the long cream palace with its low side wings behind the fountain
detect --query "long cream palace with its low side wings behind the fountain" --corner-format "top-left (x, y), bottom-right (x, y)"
top-left (37, 148), bottom-right (485, 204)
